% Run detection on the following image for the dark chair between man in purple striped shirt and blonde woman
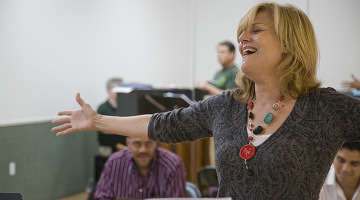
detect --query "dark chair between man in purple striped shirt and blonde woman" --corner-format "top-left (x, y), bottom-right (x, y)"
top-left (197, 166), bottom-right (219, 197)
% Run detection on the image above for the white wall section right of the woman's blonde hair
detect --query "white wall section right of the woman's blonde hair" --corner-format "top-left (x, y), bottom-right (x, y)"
top-left (309, 0), bottom-right (360, 89)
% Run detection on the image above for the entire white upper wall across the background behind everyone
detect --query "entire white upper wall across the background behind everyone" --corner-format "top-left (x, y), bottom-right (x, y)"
top-left (0, 0), bottom-right (360, 126)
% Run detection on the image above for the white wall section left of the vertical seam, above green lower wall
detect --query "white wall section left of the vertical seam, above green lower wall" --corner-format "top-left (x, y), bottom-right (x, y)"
top-left (0, 0), bottom-right (193, 124)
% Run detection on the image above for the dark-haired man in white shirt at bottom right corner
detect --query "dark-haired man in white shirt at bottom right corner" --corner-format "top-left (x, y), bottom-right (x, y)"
top-left (320, 142), bottom-right (360, 200)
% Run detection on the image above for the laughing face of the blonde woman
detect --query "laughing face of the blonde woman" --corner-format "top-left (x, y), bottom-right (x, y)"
top-left (239, 11), bottom-right (286, 81)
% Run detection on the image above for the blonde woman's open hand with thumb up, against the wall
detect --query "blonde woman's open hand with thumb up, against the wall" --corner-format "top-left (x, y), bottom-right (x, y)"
top-left (51, 93), bottom-right (99, 136)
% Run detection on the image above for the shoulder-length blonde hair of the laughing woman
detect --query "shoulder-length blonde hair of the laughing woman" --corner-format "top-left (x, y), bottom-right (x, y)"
top-left (234, 3), bottom-right (320, 103)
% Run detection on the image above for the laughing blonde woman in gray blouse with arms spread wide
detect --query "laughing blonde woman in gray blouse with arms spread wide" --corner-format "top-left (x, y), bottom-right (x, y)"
top-left (53, 3), bottom-right (360, 200)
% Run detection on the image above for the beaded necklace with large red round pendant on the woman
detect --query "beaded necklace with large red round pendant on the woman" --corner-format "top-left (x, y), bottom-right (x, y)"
top-left (239, 90), bottom-right (287, 175)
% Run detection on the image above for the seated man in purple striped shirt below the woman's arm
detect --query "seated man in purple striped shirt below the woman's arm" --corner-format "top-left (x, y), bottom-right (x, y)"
top-left (95, 137), bottom-right (186, 200)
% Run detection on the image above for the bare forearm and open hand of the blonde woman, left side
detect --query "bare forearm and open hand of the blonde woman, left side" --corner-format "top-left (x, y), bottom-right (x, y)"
top-left (51, 93), bottom-right (151, 138)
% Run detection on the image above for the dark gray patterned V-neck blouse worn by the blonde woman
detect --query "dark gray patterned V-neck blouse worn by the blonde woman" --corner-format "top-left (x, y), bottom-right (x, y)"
top-left (149, 88), bottom-right (360, 200)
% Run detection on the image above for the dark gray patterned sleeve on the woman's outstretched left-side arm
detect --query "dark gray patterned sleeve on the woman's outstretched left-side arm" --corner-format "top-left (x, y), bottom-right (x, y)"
top-left (148, 91), bottom-right (238, 143)
